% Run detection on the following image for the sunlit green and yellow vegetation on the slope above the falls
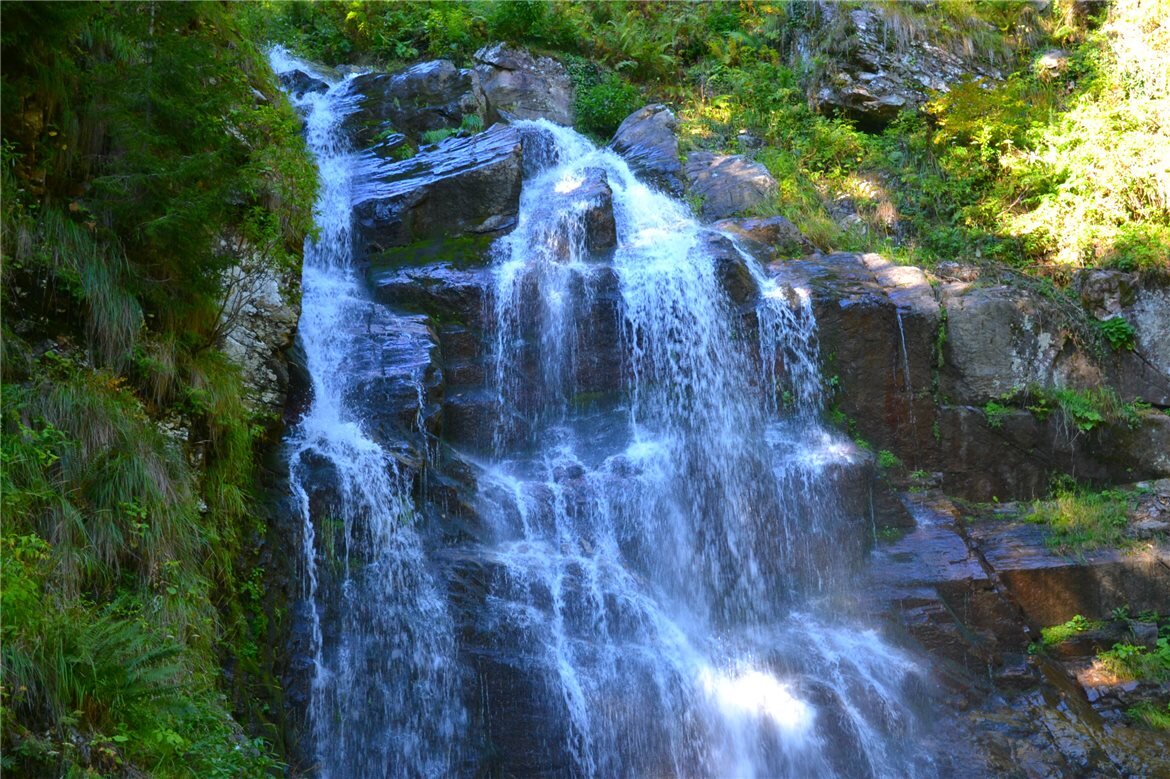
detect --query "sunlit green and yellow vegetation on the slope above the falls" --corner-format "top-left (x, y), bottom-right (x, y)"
top-left (252, 0), bottom-right (1170, 272)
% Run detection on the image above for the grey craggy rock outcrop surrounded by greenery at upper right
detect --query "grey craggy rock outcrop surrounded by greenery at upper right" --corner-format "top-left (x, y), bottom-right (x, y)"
top-left (798, 2), bottom-right (1000, 130)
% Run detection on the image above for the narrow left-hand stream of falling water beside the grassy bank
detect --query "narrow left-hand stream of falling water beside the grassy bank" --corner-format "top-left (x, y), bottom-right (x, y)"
top-left (271, 49), bottom-right (464, 779)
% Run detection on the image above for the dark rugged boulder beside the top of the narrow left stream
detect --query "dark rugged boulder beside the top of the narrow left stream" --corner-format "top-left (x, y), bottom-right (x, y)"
top-left (342, 60), bottom-right (487, 149)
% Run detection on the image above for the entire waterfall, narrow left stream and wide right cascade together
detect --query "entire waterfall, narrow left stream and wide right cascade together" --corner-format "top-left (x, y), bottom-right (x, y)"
top-left (273, 45), bottom-right (931, 778)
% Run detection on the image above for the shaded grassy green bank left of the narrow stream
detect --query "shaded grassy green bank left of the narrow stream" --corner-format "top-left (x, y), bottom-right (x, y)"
top-left (0, 2), bottom-right (315, 777)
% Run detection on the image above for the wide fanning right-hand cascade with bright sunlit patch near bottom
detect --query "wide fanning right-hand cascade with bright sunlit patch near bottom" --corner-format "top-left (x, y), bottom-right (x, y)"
top-left (470, 123), bottom-right (929, 777)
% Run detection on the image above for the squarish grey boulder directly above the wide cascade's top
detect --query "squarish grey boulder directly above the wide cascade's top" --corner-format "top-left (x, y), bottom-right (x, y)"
top-left (475, 43), bottom-right (573, 126)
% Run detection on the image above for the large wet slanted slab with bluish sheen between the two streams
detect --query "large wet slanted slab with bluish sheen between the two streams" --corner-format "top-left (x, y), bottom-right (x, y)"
top-left (353, 125), bottom-right (522, 250)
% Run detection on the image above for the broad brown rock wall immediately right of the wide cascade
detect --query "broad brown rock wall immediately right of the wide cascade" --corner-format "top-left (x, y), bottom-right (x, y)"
top-left (769, 254), bottom-right (1170, 499)
